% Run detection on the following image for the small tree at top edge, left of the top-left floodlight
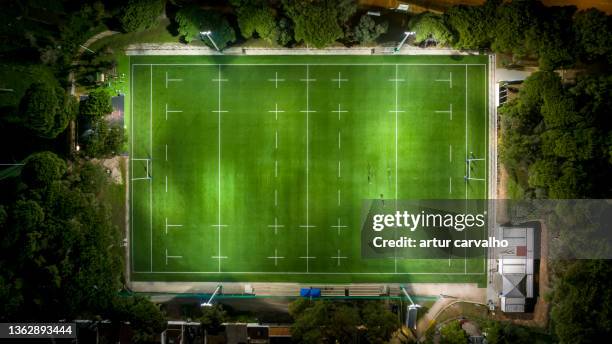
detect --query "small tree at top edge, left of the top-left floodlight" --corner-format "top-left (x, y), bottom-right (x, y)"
top-left (118, 0), bottom-right (164, 32)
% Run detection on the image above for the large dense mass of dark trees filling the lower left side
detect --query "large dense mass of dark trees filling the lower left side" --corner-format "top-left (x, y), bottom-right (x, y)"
top-left (0, 152), bottom-right (123, 320)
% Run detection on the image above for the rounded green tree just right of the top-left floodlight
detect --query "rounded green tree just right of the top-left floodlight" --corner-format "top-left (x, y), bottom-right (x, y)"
top-left (236, 6), bottom-right (280, 43)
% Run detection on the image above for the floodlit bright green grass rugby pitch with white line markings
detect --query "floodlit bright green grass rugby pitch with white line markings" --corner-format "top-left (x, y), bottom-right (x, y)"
top-left (128, 56), bottom-right (488, 285)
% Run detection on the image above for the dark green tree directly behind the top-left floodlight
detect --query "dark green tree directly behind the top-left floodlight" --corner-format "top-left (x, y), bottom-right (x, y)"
top-left (175, 6), bottom-right (236, 49)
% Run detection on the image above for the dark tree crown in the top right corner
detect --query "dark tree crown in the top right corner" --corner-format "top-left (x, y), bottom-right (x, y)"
top-left (573, 8), bottom-right (612, 62)
